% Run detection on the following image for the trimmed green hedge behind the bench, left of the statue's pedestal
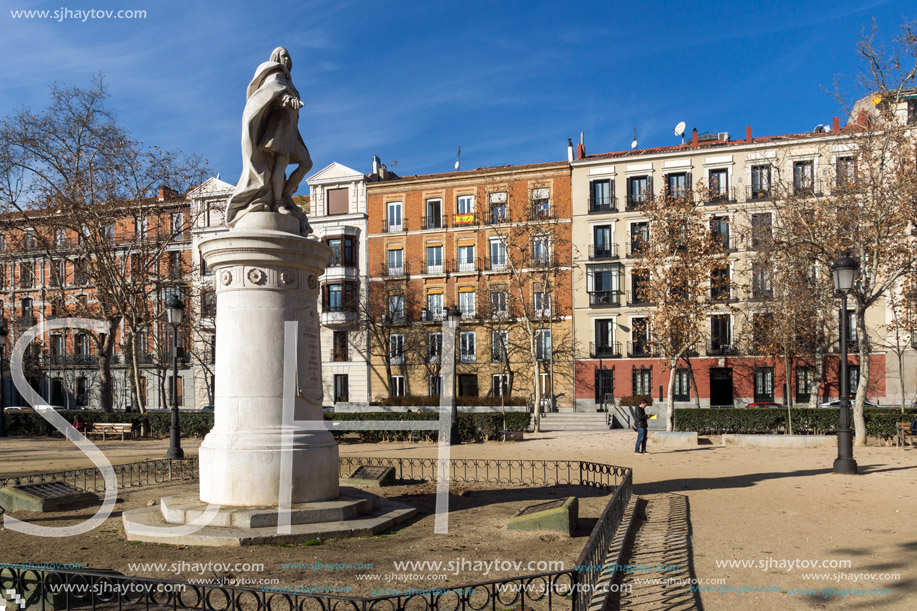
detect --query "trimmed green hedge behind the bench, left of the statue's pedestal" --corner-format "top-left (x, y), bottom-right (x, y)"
top-left (6, 411), bottom-right (213, 437)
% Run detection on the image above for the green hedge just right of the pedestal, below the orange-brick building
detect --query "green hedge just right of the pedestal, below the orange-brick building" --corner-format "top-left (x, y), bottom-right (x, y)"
top-left (328, 412), bottom-right (531, 443)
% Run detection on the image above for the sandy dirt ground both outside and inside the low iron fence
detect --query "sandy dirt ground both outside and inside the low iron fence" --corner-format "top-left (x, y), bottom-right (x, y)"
top-left (0, 431), bottom-right (917, 611)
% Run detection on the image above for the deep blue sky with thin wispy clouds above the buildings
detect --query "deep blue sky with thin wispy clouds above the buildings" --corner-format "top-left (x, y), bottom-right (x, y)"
top-left (0, 0), bottom-right (917, 191)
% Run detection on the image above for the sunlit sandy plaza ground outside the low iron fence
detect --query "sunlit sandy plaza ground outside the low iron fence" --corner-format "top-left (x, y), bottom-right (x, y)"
top-left (0, 431), bottom-right (917, 610)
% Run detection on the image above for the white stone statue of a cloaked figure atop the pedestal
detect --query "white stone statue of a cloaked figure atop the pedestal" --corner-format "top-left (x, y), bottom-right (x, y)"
top-left (226, 47), bottom-right (312, 235)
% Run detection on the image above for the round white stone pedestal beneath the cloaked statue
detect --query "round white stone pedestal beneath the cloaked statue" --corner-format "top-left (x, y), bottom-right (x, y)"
top-left (199, 212), bottom-right (339, 507)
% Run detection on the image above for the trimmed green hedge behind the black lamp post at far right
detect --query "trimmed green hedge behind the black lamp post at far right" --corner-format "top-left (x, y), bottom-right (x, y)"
top-left (675, 407), bottom-right (917, 439)
